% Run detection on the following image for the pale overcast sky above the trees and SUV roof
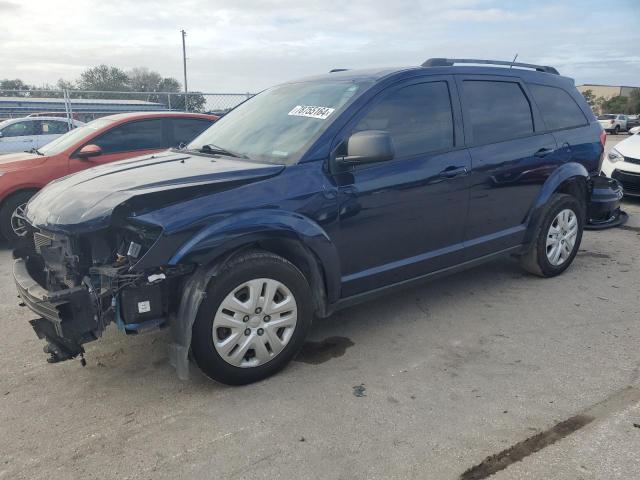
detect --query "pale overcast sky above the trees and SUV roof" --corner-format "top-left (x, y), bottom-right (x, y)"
top-left (0, 0), bottom-right (640, 92)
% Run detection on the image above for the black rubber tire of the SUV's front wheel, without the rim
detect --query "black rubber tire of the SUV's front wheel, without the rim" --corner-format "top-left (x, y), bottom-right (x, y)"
top-left (191, 251), bottom-right (313, 385)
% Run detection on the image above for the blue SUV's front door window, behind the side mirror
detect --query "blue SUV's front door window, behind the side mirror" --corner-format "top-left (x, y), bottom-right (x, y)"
top-left (354, 82), bottom-right (453, 158)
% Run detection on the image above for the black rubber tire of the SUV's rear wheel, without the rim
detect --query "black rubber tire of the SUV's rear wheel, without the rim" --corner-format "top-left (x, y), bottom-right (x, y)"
top-left (520, 193), bottom-right (585, 277)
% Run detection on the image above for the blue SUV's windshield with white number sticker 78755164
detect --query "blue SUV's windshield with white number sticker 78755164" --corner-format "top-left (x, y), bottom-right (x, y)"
top-left (187, 81), bottom-right (369, 165)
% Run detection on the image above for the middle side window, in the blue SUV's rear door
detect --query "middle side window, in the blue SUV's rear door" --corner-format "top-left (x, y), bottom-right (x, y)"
top-left (463, 80), bottom-right (533, 144)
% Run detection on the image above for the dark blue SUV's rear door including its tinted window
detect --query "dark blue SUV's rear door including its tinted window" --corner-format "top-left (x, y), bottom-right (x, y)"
top-left (457, 75), bottom-right (560, 259)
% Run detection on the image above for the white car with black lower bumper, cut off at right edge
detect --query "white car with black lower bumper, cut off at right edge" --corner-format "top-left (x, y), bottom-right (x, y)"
top-left (602, 127), bottom-right (640, 197)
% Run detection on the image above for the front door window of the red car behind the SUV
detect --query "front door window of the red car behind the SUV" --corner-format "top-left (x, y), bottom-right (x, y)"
top-left (91, 118), bottom-right (169, 153)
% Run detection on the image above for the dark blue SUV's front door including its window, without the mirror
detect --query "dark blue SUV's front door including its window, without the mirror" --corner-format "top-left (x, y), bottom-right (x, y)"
top-left (335, 76), bottom-right (470, 297)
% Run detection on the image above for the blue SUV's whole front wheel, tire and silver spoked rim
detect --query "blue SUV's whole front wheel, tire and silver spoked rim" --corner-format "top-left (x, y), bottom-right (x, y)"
top-left (191, 251), bottom-right (312, 385)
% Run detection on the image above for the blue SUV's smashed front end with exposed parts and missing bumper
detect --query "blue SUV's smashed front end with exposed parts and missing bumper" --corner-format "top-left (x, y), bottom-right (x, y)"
top-left (14, 223), bottom-right (193, 363)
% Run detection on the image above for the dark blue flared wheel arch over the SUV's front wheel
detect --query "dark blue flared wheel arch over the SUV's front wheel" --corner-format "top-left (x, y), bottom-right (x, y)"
top-left (169, 209), bottom-right (340, 302)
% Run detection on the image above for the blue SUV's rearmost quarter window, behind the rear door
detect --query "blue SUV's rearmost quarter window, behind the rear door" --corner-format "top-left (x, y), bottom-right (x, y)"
top-left (529, 84), bottom-right (587, 130)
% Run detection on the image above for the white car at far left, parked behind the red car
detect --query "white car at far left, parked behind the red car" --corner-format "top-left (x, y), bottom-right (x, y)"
top-left (0, 117), bottom-right (84, 154)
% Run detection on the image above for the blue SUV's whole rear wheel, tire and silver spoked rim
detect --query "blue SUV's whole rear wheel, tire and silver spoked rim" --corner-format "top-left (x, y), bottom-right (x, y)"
top-left (521, 194), bottom-right (585, 277)
